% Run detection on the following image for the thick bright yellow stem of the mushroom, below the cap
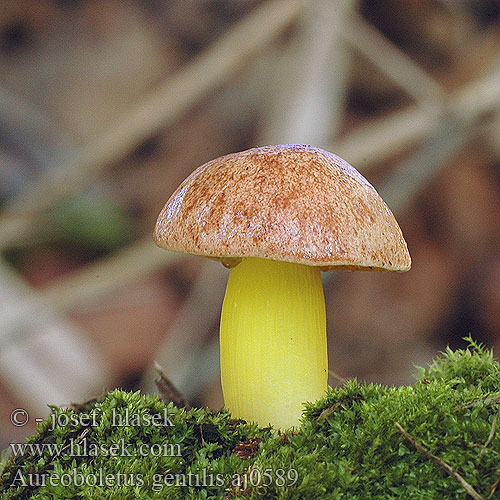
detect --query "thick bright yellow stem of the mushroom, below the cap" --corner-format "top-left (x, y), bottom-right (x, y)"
top-left (220, 258), bottom-right (328, 429)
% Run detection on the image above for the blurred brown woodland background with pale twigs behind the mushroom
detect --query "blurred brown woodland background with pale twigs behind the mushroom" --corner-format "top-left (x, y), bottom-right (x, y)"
top-left (0, 0), bottom-right (500, 448)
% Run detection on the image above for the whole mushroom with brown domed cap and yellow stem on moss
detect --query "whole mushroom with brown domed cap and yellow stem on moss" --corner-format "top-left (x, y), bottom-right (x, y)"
top-left (154, 145), bottom-right (411, 428)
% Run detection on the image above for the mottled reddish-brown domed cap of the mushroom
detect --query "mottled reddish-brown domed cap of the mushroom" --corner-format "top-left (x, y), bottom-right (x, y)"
top-left (154, 144), bottom-right (411, 271)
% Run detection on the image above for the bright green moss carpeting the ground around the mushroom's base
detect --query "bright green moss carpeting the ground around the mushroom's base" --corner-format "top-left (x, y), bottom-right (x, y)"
top-left (0, 342), bottom-right (500, 500)
